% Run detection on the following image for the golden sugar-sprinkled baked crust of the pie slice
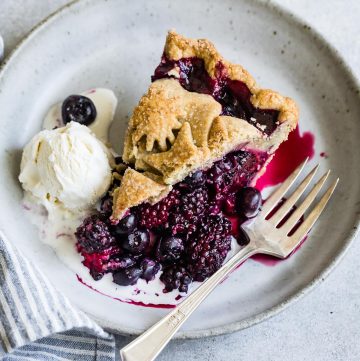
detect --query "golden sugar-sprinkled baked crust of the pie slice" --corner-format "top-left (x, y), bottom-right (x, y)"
top-left (113, 31), bottom-right (298, 219)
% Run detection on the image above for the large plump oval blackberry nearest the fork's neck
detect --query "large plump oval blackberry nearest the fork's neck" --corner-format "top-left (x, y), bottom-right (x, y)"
top-left (185, 215), bottom-right (231, 282)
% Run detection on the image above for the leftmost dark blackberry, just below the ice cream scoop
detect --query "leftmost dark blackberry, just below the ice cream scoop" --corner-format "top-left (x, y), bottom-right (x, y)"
top-left (75, 214), bottom-right (115, 253)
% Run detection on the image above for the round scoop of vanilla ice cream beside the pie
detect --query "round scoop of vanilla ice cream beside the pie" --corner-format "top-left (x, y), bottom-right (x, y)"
top-left (19, 122), bottom-right (111, 213)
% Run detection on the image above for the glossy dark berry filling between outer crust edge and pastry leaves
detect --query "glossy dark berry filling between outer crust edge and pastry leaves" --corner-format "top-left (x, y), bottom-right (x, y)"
top-left (152, 55), bottom-right (279, 135)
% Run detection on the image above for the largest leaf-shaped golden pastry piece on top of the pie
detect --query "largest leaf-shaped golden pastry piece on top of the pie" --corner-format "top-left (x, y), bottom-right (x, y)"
top-left (124, 79), bottom-right (221, 162)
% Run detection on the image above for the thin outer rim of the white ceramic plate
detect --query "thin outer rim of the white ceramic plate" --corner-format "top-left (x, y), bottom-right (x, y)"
top-left (0, 0), bottom-right (360, 339)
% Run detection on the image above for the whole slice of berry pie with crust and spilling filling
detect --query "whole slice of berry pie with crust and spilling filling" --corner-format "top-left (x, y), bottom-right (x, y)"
top-left (77, 31), bottom-right (298, 292)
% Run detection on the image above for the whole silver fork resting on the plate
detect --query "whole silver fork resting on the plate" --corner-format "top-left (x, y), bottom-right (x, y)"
top-left (120, 159), bottom-right (339, 361)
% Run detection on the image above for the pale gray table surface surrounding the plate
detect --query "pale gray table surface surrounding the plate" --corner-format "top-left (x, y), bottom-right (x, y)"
top-left (0, 0), bottom-right (360, 361)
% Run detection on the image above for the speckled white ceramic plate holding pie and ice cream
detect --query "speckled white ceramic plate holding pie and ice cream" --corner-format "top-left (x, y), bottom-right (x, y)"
top-left (0, 0), bottom-right (360, 337)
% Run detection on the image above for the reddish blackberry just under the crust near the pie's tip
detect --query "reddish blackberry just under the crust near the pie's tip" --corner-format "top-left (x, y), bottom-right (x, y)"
top-left (137, 189), bottom-right (180, 229)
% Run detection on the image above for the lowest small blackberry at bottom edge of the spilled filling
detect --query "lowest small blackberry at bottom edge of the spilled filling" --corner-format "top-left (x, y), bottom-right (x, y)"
top-left (160, 264), bottom-right (192, 293)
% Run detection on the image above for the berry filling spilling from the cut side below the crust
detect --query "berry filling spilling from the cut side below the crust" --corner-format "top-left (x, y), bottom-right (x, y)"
top-left (76, 150), bottom-right (268, 292)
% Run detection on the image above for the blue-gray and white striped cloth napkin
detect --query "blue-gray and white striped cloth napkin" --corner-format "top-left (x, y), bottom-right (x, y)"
top-left (0, 234), bottom-right (116, 361)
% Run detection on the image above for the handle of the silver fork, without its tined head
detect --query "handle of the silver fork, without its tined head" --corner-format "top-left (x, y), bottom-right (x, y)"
top-left (120, 242), bottom-right (257, 361)
